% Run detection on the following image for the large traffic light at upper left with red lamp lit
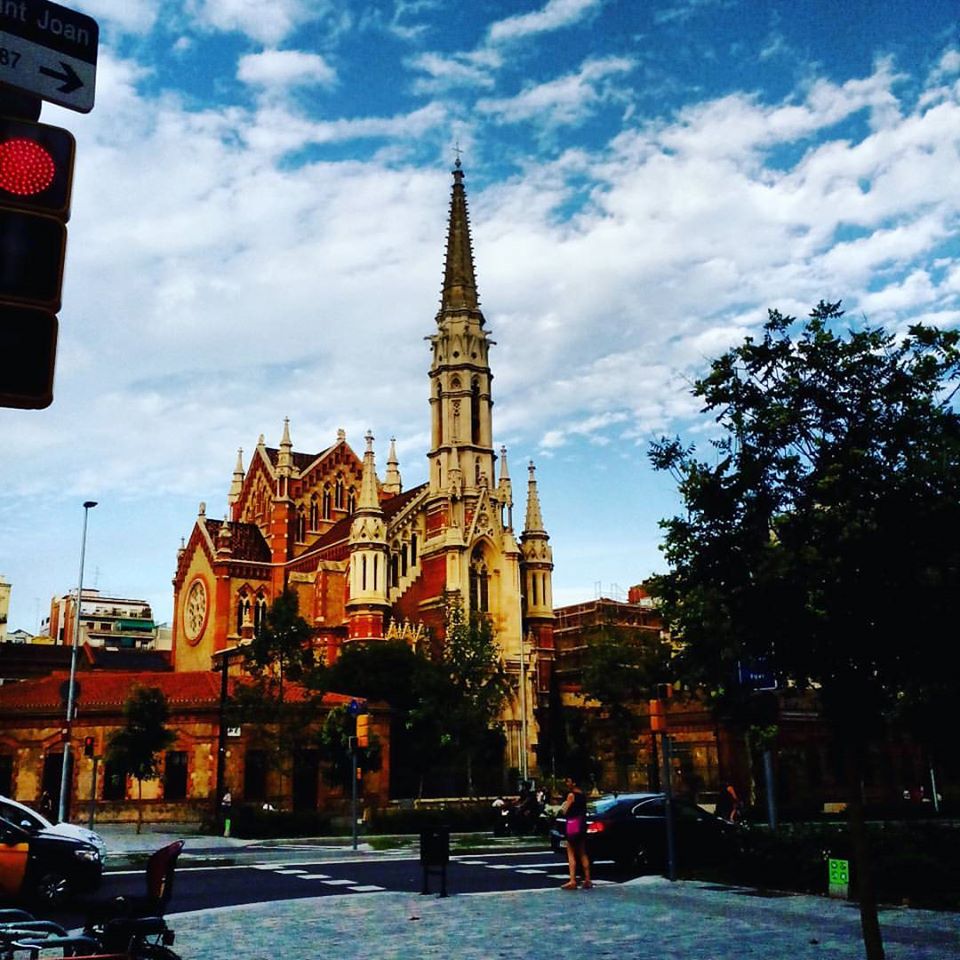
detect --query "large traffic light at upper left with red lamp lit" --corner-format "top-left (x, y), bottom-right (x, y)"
top-left (0, 117), bottom-right (76, 409)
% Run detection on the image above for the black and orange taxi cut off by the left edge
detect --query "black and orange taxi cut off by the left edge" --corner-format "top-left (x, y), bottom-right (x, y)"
top-left (0, 817), bottom-right (103, 905)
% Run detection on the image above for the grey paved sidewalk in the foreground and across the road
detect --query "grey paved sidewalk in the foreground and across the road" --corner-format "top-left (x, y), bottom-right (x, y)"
top-left (92, 825), bottom-right (960, 960)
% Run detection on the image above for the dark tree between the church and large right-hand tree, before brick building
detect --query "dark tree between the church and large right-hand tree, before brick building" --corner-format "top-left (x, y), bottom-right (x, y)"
top-left (581, 626), bottom-right (672, 788)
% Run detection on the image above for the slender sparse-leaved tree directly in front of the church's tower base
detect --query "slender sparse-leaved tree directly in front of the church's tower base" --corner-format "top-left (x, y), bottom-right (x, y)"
top-left (441, 593), bottom-right (511, 796)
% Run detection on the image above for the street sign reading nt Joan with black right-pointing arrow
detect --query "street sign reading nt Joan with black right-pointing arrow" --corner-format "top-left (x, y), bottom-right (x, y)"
top-left (0, 0), bottom-right (100, 113)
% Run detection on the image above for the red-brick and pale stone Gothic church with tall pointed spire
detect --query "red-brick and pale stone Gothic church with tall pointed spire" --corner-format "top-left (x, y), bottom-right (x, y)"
top-left (173, 159), bottom-right (554, 773)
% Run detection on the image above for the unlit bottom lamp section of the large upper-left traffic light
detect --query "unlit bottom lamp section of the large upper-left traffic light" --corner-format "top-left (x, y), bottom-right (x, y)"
top-left (0, 303), bottom-right (57, 406)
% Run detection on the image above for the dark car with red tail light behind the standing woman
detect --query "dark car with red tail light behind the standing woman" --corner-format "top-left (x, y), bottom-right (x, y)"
top-left (550, 793), bottom-right (736, 870)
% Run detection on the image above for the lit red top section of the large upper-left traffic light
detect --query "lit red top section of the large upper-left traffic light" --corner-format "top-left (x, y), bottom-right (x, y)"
top-left (0, 117), bottom-right (76, 220)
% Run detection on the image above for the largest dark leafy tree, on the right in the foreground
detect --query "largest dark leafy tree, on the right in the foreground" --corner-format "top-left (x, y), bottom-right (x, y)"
top-left (651, 301), bottom-right (960, 960)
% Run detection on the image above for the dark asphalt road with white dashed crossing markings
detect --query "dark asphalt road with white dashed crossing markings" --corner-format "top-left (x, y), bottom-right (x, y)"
top-left (50, 848), bottom-right (626, 926)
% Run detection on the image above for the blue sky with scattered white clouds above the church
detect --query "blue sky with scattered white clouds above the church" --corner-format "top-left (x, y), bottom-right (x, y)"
top-left (0, 0), bottom-right (960, 632)
